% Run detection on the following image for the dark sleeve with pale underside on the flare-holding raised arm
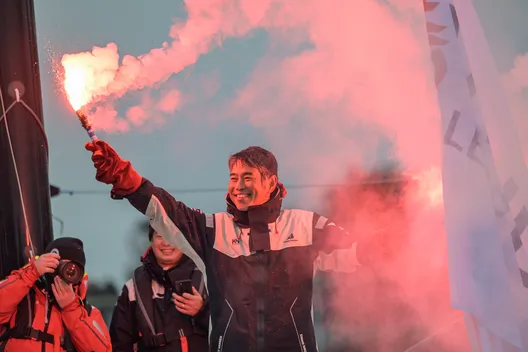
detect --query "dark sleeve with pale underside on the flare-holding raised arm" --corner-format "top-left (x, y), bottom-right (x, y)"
top-left (126, 178), bottom-right (212, 270)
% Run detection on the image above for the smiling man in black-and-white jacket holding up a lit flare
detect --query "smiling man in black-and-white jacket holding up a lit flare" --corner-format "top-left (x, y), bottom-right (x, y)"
top-left (86, 141), bottom-right (376, 352)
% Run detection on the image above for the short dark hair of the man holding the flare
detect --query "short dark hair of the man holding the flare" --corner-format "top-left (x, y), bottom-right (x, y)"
top-left (228, 146), bottom-right (279, 177)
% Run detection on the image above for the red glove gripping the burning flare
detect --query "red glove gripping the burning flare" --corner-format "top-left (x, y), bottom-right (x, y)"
top-left (84, 140), bottom-right (142, 196)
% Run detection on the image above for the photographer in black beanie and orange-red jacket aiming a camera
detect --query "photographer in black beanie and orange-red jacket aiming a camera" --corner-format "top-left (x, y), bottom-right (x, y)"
top-left (0, 237), bottom-right (112, 352)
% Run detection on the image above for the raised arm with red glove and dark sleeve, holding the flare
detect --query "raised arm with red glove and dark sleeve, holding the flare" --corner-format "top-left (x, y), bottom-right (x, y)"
top-left (85, 140), bottom-right (211, 269)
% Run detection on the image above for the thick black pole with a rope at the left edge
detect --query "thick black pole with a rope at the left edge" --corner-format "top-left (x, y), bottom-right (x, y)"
top-left (0, 0), bottom-right (53, 277)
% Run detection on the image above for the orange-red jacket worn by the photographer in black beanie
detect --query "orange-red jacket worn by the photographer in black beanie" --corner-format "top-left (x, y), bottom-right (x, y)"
top-left (0, 262), bottom-right (112, 352)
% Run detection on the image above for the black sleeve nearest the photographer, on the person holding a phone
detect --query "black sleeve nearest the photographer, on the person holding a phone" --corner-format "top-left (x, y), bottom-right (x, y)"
top-left (110, 285), bottom-right (139, 352)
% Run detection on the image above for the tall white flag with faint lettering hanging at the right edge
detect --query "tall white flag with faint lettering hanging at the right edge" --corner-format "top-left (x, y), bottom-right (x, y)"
top-left (424, 0), bottom-right (528, 352)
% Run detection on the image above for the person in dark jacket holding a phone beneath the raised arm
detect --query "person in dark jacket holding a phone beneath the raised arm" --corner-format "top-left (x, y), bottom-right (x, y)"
top-left (110, 227), bottom-right (209, 352)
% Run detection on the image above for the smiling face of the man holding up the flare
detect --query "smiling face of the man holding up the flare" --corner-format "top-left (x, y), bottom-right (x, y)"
top-left (227, 161), bottom-right (277, 211)
